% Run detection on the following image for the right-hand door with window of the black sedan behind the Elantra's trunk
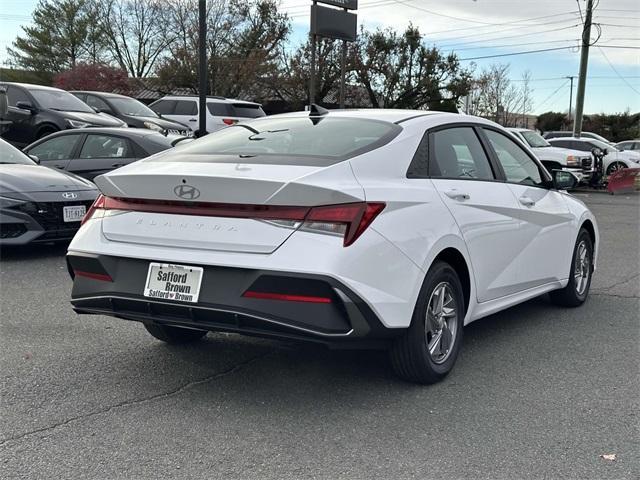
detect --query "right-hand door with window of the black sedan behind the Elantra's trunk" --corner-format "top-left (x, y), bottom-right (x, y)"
top-left (68, 133), bottom-right (137, 180)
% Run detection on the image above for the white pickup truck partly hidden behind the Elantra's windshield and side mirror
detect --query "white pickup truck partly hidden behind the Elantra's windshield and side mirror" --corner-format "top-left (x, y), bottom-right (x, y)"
top-left (507, 128), bottom-right (593, 181)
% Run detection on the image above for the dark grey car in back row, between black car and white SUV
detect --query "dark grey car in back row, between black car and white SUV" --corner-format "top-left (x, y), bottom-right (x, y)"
top-left (70, 91), bottom-right (192, 136)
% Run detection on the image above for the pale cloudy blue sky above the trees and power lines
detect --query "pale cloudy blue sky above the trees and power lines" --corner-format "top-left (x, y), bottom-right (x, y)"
top-left (0, 0), bottom-right (640, 113)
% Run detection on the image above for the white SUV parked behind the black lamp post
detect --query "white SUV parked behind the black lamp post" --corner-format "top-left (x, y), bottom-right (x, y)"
top-left (149, 95), bottom-right (266, 133)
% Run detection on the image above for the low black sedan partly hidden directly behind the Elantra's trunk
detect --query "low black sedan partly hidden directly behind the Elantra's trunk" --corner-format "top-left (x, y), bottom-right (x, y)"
top-left (23, 128), bottom-right (188, 180)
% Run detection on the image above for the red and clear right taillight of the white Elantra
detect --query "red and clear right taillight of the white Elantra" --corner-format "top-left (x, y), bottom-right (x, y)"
top-left (302, 202), bottom-right (385, 247)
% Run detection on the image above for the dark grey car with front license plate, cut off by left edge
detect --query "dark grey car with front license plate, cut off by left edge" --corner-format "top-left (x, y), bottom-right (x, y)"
top-left (0, 140), bottom-right (98, 246)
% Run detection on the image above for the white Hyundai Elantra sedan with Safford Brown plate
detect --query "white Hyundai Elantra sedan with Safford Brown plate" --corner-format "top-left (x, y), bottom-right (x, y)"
top-left (67, 106), bottom-right (599, 383)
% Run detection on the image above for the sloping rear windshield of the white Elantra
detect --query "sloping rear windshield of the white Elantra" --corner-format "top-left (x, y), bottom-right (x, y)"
top-left (151, 117), bottom-right (402, 165)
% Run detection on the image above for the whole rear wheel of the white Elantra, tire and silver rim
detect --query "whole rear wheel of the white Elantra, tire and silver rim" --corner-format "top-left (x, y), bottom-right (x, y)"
top-left (390, 261), bottom-right (465, 384)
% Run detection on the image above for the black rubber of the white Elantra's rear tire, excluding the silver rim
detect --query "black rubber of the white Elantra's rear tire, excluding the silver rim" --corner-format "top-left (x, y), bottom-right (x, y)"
top-left (390, 261), bottom-right (465, 384)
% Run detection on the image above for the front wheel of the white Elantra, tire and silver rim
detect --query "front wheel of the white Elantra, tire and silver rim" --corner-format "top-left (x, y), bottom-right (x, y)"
top-left (549, 228), bottom-right (593, 307)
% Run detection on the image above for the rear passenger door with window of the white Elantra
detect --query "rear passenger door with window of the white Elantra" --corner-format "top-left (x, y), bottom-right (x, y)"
top-left (428, 125), bottom-right (523, 302)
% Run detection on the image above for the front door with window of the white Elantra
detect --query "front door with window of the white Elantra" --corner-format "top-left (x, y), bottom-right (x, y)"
top-left (483, 127), bottom-right (576, 290)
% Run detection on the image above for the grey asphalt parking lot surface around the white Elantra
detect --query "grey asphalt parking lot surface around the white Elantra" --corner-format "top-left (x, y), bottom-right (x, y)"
top-left (0, 194), bottom-right (640, 479)
